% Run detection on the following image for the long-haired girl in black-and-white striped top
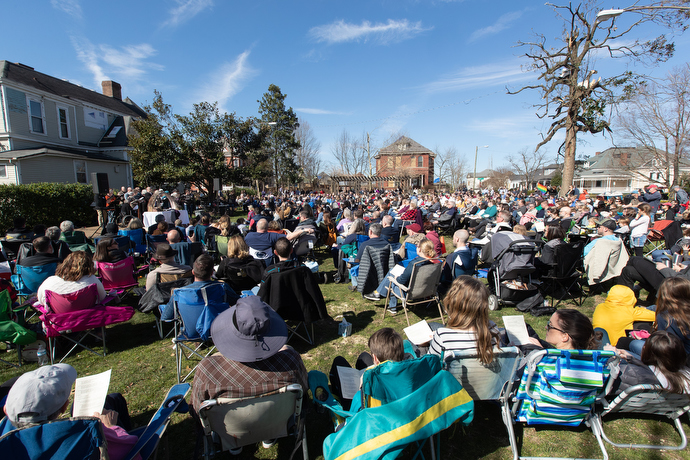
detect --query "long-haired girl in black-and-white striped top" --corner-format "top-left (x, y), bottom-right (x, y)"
top-left (429, 275), bottom-right (498, 364)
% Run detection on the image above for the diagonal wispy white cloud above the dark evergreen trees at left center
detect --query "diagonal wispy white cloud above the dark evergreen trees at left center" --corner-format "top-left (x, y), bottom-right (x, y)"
top-left (194, 50), bottom-right (258, 111)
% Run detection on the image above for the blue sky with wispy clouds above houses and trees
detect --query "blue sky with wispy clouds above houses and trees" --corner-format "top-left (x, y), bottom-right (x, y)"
top-left (6, 0), bottom-right (690, 174)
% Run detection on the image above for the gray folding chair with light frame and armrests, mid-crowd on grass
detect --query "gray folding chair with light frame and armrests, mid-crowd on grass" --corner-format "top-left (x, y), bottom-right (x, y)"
top-left (383, 259), bottom-right (445, 326)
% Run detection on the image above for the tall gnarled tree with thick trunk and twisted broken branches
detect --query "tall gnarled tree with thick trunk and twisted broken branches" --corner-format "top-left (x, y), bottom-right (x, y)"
top-left (508, 0), bottom-right (687, 195)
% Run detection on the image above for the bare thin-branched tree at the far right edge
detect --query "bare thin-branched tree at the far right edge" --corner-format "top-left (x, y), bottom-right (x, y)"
top-left (618, 64), bottom-right (690, 187)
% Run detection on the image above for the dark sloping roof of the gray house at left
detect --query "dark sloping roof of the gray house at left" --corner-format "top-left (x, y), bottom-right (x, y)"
top-left (0, 61), bottom-right (146, 118)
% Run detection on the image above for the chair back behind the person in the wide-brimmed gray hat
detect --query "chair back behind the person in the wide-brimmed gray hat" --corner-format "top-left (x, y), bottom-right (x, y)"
top-left (197, 383), bottom-right (309, 460)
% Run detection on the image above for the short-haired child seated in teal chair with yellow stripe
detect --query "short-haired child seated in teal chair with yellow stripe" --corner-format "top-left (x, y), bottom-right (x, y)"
top-left (328, 327), bottom-right (405, 412)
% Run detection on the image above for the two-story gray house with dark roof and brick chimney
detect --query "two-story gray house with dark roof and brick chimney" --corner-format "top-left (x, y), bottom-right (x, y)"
top-left (0, 61), bottom-right (146, 189)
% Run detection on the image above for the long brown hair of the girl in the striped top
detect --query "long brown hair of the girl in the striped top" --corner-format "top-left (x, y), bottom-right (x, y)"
top-left (443, 275), bottom-right (498, 364)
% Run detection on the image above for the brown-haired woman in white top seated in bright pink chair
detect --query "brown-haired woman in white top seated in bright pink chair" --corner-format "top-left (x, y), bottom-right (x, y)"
top-left (37, 251), bottom-right (106, 305)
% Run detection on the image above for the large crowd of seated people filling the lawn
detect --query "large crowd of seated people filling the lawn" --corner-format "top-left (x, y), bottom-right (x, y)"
top-left (0, 185), bottom-right (690, 458)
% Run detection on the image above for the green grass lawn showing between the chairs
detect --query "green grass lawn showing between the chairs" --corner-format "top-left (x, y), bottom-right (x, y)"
top-left (0, 243), bottom-right (690, 459)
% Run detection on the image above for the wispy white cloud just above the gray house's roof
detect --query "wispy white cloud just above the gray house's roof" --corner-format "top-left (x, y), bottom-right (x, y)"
top-left (72, 37), bottom-right (164, 88)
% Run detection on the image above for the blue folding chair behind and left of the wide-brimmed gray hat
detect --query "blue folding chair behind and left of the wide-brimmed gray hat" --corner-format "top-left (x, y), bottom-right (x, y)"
top-left (168, 283), bottom-right (230, 383)
